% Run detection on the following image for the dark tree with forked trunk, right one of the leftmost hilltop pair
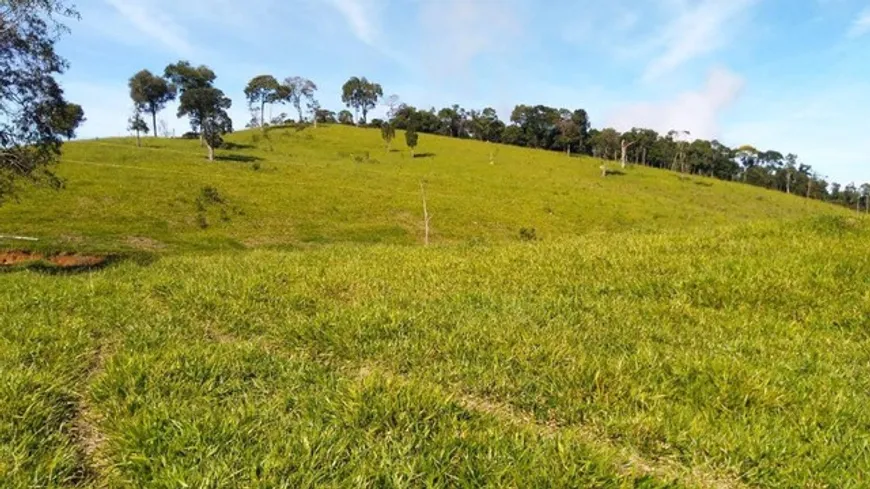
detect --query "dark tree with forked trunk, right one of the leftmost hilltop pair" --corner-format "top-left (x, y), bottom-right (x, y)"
top-left (181, 87), bottom-right (233, 161)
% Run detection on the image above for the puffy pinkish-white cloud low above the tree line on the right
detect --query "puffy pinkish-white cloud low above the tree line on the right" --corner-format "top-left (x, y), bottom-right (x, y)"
top-left (607, 68), bottom-right (744, 139)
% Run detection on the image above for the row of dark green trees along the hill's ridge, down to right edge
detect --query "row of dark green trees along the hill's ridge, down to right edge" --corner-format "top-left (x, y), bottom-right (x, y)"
top-left (130, 61), bottom-right (870, 211)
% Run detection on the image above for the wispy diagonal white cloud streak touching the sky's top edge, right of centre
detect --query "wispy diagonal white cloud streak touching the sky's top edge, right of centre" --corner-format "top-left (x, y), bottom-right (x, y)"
top-left (644, 0), bottom-right (756, 80)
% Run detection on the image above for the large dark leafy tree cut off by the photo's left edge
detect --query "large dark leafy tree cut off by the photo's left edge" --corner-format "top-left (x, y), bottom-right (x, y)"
top-left (0, 0), bottom-right (78, 198)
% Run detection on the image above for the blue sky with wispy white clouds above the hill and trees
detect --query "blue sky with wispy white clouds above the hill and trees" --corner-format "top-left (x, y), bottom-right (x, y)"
top-left (60, 0), bottom-right (870, 183)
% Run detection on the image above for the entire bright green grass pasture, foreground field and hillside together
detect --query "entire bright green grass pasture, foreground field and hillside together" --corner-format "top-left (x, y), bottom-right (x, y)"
top-left (0, 127), bottom-right (870, 488)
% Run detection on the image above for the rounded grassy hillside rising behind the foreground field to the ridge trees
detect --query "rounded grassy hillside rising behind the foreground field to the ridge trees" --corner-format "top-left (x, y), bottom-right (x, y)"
top-left (0, 126), bottom-right (842, 250)
